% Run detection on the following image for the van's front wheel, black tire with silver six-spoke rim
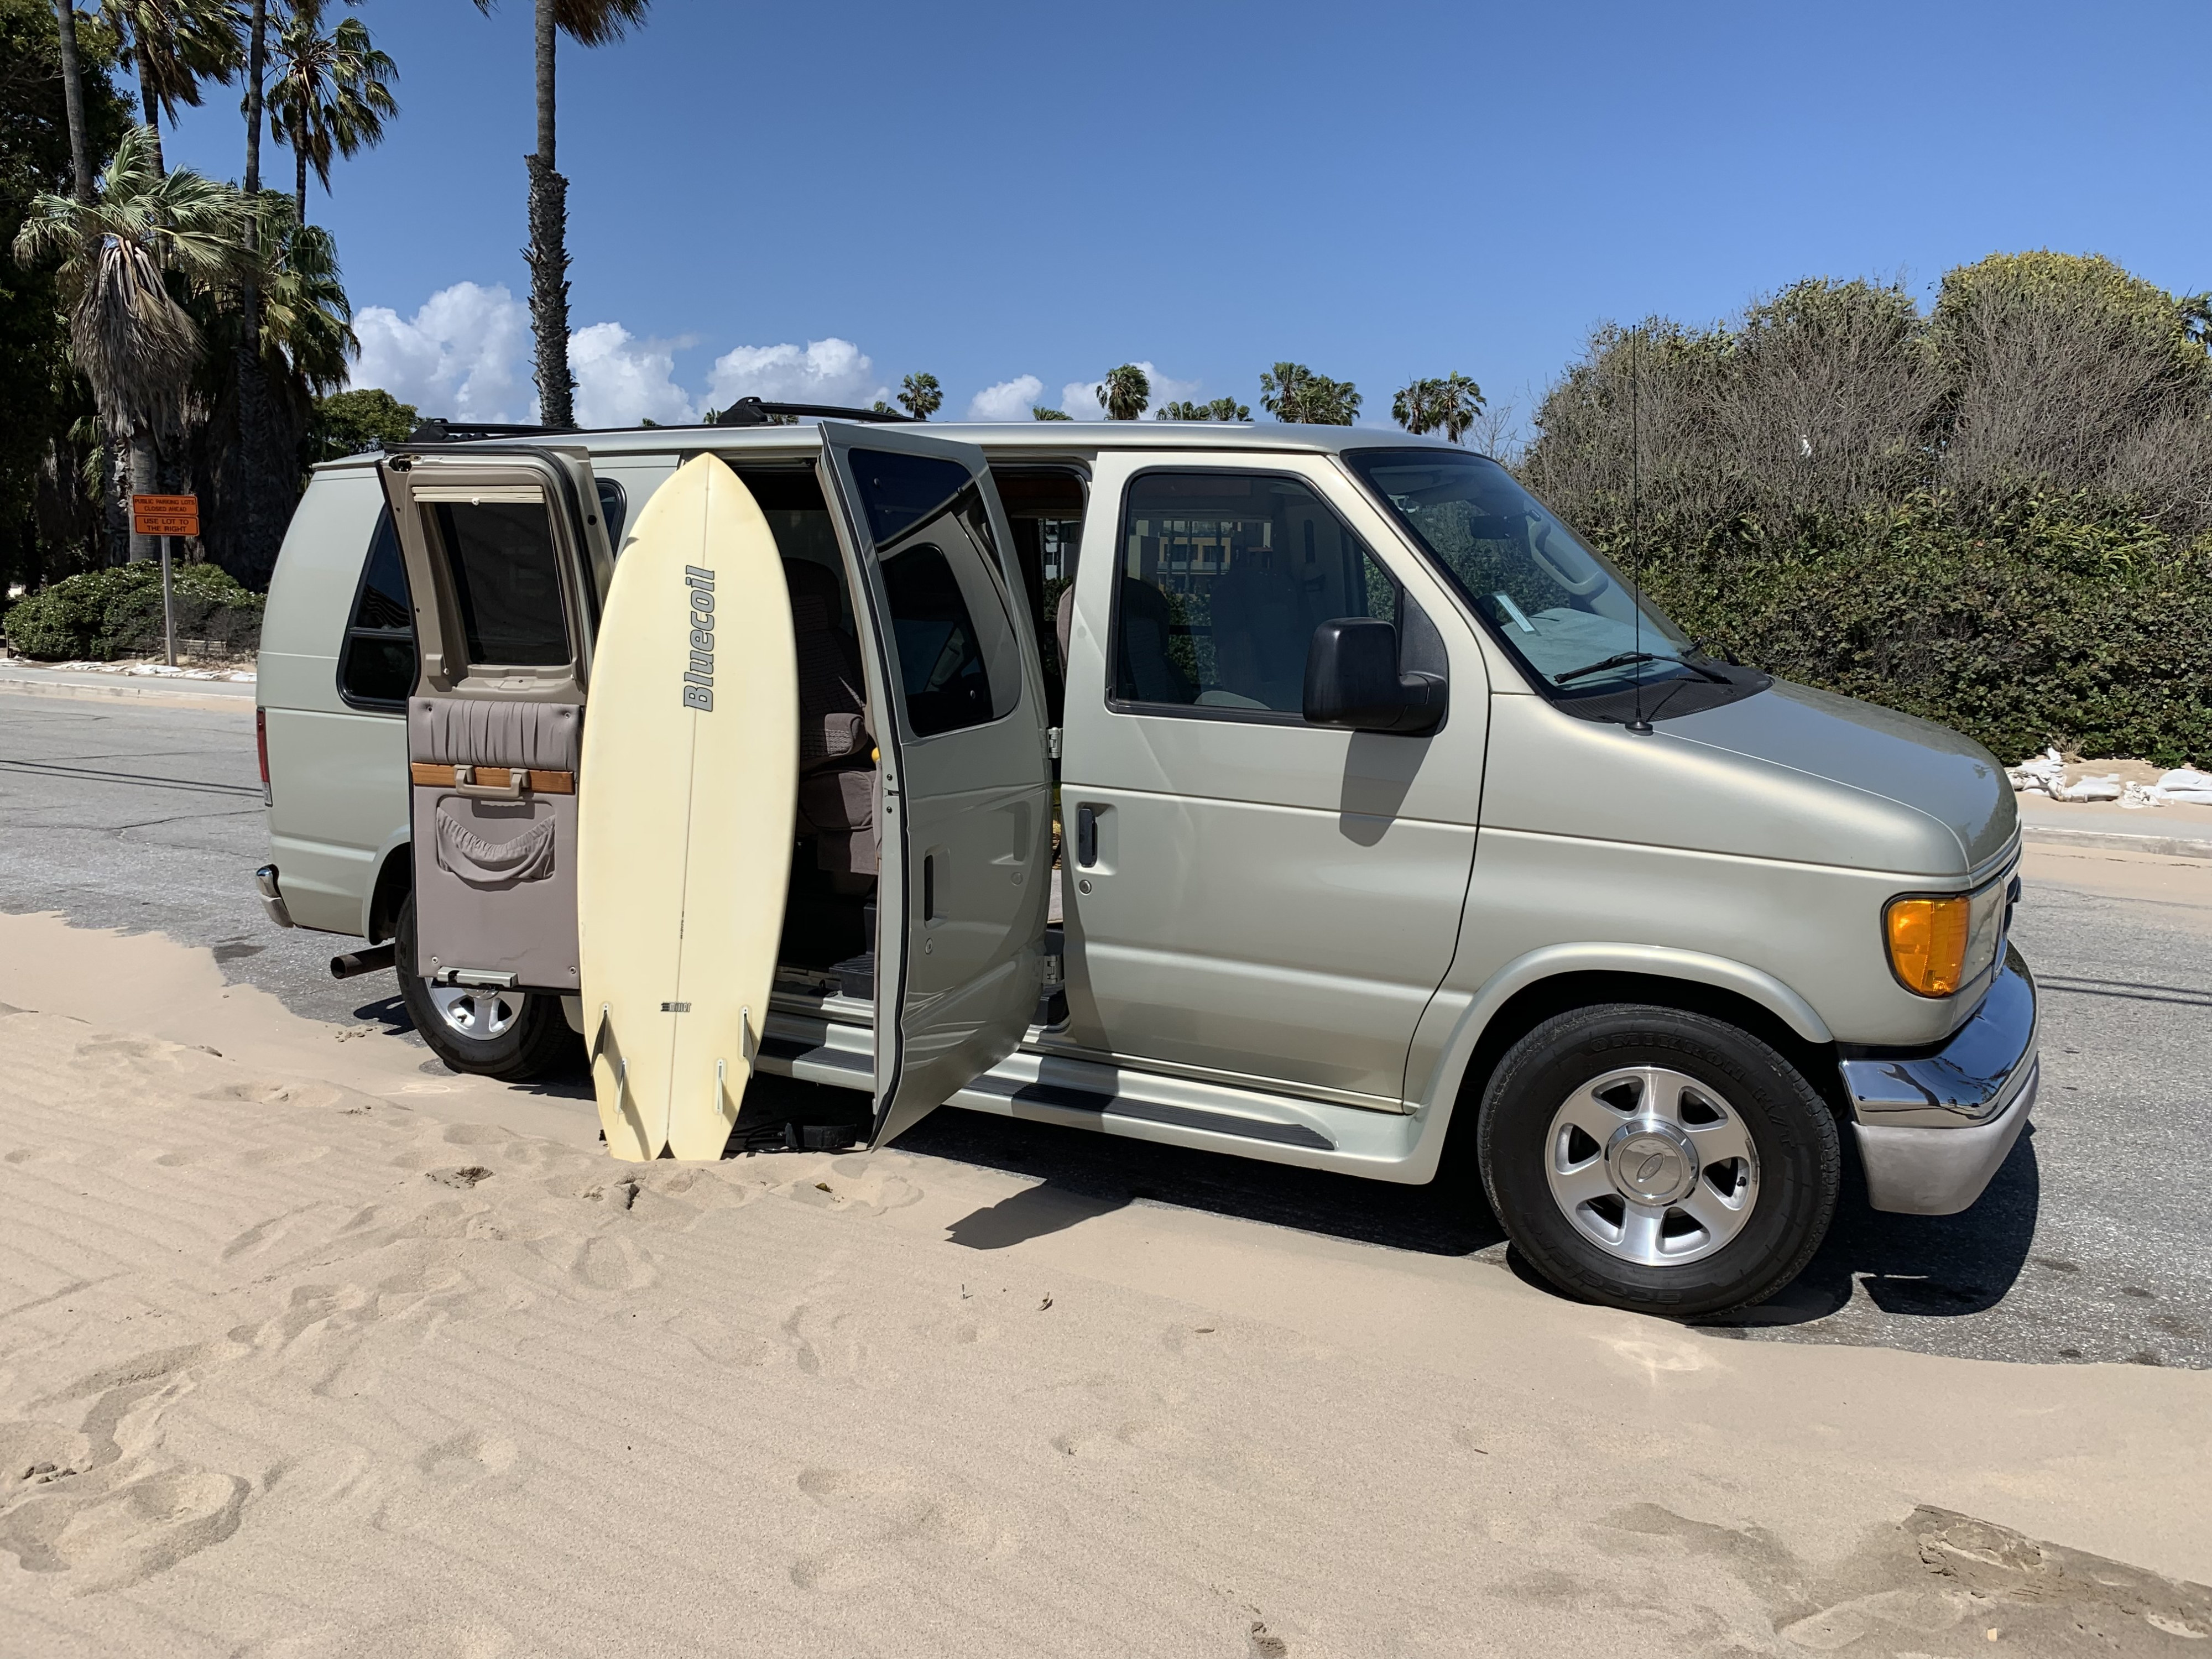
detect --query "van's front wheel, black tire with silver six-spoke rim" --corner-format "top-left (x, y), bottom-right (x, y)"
top-left (1475, 1002), bottom-right (1843, 1318)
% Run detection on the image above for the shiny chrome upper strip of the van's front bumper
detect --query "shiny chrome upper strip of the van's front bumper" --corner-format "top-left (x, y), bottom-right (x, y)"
top-left (1836, 945), bottom-right (2039, 1133)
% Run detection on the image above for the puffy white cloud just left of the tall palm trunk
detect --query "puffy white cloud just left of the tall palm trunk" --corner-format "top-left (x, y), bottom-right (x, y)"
top-left (349, 283), bottom-right (538, 420)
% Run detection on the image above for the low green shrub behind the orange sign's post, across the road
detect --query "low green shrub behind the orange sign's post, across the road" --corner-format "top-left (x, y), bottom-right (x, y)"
top-left (0, 560), bottom-right (265, 661)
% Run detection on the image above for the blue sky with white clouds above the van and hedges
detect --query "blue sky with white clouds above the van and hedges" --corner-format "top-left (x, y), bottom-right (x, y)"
top-left (156, 0), bottom-right (2212, 429)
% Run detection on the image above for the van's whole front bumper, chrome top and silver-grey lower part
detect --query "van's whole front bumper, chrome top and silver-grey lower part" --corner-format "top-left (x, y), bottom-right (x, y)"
top-left (1840, 945), bottom-right (2039, 1214)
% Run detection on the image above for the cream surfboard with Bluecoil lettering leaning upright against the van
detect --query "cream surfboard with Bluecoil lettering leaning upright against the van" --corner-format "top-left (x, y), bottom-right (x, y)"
top-left (577, 456), bottom-right (799, 1159)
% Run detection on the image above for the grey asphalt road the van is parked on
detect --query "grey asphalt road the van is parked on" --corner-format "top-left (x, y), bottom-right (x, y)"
top-left (0, 690), bottom-right (2212, 1367)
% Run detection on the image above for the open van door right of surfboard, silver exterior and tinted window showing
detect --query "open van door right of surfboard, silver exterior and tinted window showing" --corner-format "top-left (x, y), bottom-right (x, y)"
top-left (823, 422), bottom-right (1053, 1146)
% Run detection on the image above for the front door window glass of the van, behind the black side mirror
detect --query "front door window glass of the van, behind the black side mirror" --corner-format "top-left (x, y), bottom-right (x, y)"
top-left (1110, 471), bottom-right (1405, 714)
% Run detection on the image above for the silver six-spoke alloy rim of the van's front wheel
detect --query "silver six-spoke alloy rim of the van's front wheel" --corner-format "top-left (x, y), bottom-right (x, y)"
top-left (1544, 1066), bottom-right (1759, 1267)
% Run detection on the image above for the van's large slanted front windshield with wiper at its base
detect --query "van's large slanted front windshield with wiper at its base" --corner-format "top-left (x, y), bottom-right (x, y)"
top-left (1345, 449), bottom-right (1728, 699)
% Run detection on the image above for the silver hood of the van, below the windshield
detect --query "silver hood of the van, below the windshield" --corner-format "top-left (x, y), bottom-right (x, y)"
top-left (1659, 679), bottom-right (2020, 872)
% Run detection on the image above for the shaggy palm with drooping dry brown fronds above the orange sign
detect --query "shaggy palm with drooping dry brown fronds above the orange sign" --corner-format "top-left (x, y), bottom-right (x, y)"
top-left (15, 126), bottom-right (246, 560)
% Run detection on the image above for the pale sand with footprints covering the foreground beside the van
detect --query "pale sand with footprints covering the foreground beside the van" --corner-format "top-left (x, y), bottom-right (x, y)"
top-left (0, 916), bottom-right (2212, 1659)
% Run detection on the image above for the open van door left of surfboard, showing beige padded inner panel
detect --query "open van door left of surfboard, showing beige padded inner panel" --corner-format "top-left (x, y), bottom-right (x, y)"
top-left (383, 449), bottom-right (615, 995)
